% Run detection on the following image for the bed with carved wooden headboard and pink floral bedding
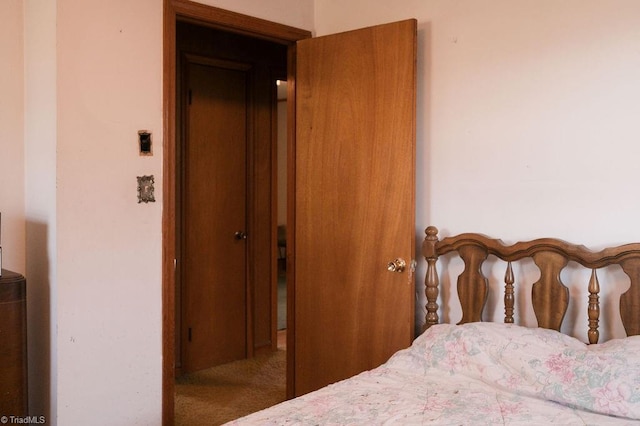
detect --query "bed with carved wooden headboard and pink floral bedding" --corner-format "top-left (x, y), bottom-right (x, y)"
top-left (231, 226), bottom-right (640, 425)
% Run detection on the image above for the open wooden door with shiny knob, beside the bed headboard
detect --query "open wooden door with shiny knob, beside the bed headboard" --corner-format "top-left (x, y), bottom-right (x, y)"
top-left (288, 20), bottom-right (416, 396)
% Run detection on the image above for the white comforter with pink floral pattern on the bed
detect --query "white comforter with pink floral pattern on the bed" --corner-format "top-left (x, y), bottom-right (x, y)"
top-left (232, 323), bottom-right (640, 425)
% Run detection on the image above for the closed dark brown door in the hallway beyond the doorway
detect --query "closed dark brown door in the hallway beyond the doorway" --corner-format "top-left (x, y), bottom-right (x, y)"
top-left (182, 61), bottom-right (247, 372)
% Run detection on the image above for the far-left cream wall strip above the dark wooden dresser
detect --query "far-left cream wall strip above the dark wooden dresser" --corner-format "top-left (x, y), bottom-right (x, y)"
top-left (0, 0), bottom-right (26, 274)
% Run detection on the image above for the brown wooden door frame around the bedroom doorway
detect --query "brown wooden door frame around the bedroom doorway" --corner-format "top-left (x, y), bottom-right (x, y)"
top-left (162, 0), bottom-right (311, 425)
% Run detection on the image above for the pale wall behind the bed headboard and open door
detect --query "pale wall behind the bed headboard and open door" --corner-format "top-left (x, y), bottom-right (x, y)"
top-left (315, 0), bottom-right (640, 340)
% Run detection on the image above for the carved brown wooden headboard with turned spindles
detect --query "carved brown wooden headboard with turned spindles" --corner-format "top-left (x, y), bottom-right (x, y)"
top-left (422, 226), bottom-right (640, 343)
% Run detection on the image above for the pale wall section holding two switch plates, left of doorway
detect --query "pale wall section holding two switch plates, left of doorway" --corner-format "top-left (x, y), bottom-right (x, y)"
top-left (56, 0), bottom-right (162, 425)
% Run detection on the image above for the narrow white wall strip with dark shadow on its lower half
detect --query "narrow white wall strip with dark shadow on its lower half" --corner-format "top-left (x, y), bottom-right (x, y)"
top-left (23, 0), bottom-right (57, 419)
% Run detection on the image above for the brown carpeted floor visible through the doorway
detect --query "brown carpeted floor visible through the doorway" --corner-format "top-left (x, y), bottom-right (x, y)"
top-left (175, 350), bottom-right (286, 426)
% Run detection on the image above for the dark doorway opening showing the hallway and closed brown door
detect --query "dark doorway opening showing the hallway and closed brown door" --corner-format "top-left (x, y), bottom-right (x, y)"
top-left (176, 22), bottom-right (287, 422)
